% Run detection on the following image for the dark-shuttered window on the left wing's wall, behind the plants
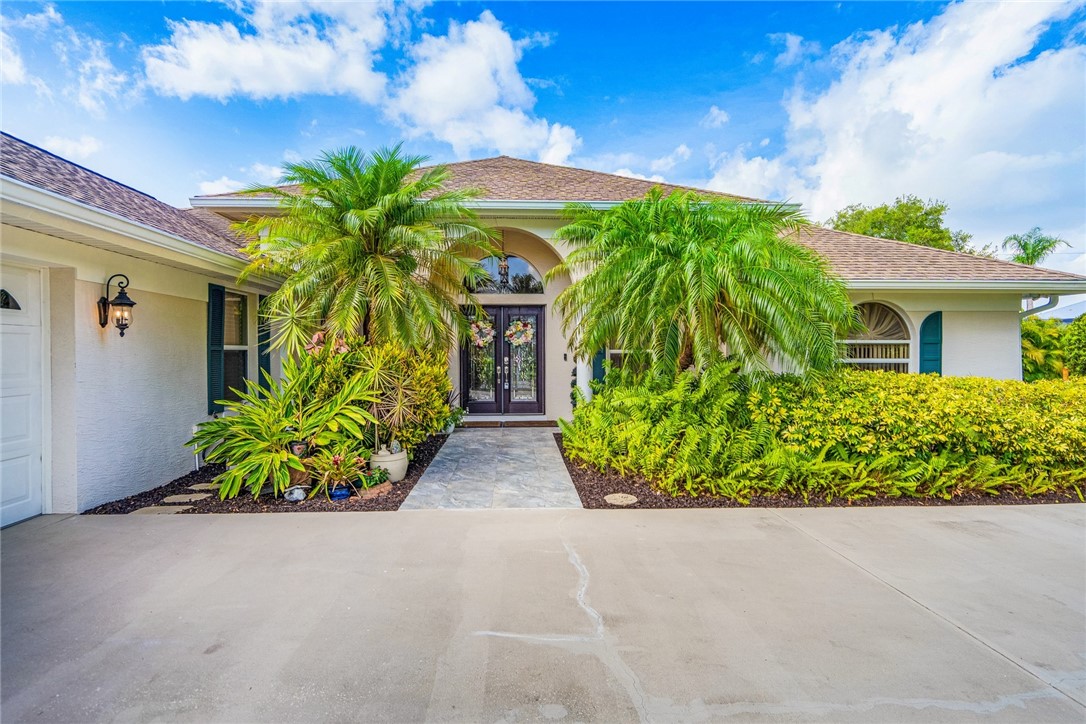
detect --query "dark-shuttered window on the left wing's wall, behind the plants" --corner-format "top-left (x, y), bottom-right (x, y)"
top-left (207, 284), bottom-right (272, 415)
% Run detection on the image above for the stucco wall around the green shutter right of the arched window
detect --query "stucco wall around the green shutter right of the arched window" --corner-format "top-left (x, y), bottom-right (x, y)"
top-left (851, 291), bottom-right (1022, 380)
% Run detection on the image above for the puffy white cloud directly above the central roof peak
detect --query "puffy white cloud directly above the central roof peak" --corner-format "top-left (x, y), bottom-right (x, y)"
top-left (386, 11), bottom-right (581, 164)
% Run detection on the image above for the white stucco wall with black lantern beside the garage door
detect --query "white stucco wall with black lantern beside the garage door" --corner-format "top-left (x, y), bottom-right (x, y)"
top-left (0, 226), bottom-right (273, 512)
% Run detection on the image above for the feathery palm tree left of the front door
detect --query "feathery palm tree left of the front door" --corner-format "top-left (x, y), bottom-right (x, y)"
top-left (235, 145), bottom-right (495, 352)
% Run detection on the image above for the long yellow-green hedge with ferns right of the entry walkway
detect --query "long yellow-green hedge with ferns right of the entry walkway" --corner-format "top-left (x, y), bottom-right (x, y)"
top-left (561, 365), bottom-right (1086, 501)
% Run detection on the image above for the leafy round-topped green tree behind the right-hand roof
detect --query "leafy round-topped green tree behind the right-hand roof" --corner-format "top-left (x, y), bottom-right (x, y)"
top-left (825, 195), bottom-right (993, 256)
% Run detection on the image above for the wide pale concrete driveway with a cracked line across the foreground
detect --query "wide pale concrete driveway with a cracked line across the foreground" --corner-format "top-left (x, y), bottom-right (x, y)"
top-left (0, 505), bottom-right (1086, 722)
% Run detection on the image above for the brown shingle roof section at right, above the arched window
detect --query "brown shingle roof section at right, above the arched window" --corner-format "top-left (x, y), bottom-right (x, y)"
top-left (795, 226), bottom-right (1086, 282)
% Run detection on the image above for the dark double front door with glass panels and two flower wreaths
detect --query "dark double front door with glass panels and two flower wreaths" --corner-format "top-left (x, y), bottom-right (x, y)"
top-left (460, 305), bottom-right (544, 415)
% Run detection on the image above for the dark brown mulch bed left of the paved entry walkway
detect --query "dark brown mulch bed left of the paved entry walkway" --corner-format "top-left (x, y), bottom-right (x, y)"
top-left (83, 435), bottom-right (449, 516)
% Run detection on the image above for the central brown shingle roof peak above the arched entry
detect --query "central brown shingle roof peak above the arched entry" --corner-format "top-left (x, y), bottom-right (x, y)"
top-left (197, 156), bottom-right (758, 201)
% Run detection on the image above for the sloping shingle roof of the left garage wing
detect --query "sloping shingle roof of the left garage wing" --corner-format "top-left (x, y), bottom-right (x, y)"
top-left (0, 131), bottom-right (245, 258)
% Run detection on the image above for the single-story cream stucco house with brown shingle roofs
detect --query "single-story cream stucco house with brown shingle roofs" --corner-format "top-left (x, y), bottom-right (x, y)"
top-left (0, 135), bottom-right (1086, 524)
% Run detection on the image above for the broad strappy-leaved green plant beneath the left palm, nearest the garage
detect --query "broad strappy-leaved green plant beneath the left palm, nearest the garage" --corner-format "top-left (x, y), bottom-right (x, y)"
top-left (188, 355), bottom-right (378, 498)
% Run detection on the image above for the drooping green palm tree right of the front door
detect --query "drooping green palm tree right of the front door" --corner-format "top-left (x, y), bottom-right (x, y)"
top-left (547, 188), bottom-right (855, 373)
